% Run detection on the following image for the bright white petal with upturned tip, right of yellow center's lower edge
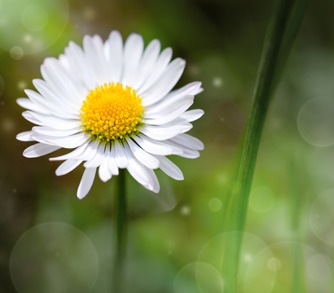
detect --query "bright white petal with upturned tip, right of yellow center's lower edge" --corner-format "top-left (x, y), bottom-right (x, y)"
top-left (140, 123), bottom-right (192, 140)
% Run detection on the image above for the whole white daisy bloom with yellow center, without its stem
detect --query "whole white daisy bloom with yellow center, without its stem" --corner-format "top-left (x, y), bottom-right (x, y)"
top-left (17, 31), bottom-right (204, 199)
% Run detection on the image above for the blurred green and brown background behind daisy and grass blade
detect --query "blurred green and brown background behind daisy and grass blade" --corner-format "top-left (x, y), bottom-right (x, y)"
top-left (0, 0), bottom-right (334, 293)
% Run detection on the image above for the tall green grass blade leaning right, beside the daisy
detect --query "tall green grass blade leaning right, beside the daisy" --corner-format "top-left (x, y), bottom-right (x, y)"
top-left (223, 0), bottom-right (307, 293)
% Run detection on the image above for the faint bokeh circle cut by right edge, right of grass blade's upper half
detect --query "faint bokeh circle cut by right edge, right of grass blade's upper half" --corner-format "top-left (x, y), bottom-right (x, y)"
top-left (297, 98), bottom-right (334, 147)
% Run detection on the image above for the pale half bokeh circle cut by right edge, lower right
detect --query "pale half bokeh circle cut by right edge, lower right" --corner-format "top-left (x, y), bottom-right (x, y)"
top-left (309, 189), bottom-right (334, 246)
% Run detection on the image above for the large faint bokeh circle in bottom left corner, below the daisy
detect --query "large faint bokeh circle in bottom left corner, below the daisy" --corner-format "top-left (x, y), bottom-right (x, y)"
top-left (10, 222), bottom-right (99, 293)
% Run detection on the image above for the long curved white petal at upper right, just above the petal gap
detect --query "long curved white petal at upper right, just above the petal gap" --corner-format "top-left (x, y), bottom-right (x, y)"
top-left (141, 58), bottom-right (186, 106)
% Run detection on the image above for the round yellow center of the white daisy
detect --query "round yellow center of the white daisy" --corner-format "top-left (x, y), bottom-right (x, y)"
top-left (81, 83), bottom-right (144, 143)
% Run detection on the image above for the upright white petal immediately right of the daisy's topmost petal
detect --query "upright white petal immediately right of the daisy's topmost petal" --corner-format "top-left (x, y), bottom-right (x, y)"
top-left (122, 34), bottom-right (144, 87)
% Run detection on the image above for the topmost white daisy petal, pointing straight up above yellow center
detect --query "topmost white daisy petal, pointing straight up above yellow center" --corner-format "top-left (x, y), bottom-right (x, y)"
top-left (104, 31), bottom-right (123, 82)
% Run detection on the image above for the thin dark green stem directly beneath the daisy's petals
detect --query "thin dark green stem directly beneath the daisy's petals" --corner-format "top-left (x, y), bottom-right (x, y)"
top-left (112, 170), bottom-right (127, 293)
